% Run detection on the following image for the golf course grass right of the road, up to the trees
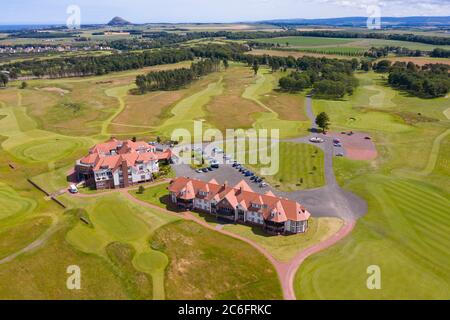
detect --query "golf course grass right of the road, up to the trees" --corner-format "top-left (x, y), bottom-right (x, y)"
top-left (295, 73), bottom-right (450, 299)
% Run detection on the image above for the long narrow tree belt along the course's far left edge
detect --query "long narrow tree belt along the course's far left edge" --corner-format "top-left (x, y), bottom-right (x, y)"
top-left (2, 49), bottom-right (194, 78)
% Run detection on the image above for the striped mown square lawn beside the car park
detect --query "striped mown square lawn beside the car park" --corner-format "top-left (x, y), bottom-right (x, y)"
top-left (248, 142), bottom-right (325, 191)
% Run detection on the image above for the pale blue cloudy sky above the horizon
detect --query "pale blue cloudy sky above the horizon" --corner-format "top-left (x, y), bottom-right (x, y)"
top-left (0, 0), bottom-right (450, 25)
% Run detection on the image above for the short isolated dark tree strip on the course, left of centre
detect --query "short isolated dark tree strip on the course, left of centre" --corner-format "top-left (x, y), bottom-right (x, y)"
top-left (136, 59), bottom-right (220, 93)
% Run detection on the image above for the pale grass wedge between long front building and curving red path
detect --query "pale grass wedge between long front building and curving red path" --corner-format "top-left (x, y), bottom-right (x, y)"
top-left (224, 218), bottom-right (343, 261)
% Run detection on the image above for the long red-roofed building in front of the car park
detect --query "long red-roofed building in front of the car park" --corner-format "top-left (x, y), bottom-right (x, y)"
top-left (168, 177), bottom-right (311, 234)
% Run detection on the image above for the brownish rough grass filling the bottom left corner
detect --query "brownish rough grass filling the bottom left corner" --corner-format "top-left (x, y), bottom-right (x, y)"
top-left (0, 215), bottom-right (128, 299)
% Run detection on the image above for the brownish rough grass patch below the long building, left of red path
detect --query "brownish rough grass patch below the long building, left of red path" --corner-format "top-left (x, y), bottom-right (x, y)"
top-left (152, 221), bottom-right (282, 300)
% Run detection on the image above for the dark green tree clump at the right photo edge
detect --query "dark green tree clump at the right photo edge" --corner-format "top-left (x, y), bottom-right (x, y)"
top-left (388, 62), bottom-right (450, 98)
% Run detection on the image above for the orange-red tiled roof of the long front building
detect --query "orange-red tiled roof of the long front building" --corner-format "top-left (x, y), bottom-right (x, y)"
top-left (168, 177), bottom-right (311, 222)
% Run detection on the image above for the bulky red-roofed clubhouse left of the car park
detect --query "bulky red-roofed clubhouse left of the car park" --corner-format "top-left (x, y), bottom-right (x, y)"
top-left (75, 138), bottom-right (172, 189)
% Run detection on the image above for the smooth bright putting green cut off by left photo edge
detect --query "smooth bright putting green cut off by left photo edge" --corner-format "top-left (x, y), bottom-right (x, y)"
top-left (0, 182), bottom-right (37, 220)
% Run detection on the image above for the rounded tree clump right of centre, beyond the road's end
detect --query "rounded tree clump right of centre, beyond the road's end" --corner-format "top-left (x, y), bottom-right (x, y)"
top-left (279, 57), bottom-right (359, 98)
